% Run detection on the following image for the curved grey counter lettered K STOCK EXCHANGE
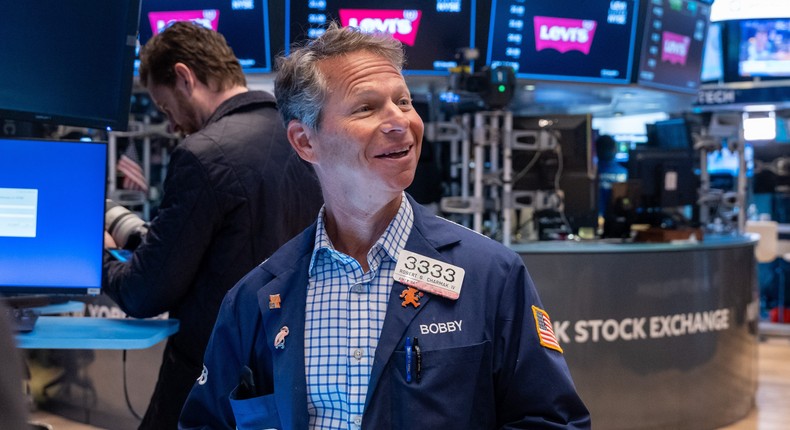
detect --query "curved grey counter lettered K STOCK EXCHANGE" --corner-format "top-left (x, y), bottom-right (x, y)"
top-left (512, 236), bottom-right (759, 430)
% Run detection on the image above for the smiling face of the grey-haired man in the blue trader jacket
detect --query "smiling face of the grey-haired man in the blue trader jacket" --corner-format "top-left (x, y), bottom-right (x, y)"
top-left (311, 51), bottom-right (423, 199)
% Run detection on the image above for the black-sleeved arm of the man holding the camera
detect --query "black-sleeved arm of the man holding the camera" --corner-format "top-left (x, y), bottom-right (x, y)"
top-left (103, 148), bottom-right (221, 318)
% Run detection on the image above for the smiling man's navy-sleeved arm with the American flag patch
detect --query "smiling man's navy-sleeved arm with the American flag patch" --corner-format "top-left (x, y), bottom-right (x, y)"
top-left (494, 261), bottom-right (590, 429)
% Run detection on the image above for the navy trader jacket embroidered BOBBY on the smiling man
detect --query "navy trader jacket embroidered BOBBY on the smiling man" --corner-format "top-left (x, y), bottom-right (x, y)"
top-left (179, 196), bottom-right (590, 430)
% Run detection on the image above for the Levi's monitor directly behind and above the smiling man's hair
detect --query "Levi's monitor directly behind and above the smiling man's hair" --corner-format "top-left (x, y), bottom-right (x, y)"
top-left (284, 0), bottom-right (477, 75)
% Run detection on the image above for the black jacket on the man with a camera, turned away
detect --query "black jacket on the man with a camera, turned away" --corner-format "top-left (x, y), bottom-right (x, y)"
top-left (104, 91), bottom-right (322, 428)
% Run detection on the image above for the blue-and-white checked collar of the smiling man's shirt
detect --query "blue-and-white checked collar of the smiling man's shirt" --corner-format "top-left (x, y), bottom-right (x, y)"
top-left (308, 192), bottom-right (414, 275)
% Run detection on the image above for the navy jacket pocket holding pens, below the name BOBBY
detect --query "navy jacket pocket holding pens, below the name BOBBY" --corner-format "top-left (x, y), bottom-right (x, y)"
top-left (389, 341), bottom-right (495, 429)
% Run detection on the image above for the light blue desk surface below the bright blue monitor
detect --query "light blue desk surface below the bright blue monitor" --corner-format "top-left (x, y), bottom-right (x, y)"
top-left (16, 316), bottom-right (178, 349)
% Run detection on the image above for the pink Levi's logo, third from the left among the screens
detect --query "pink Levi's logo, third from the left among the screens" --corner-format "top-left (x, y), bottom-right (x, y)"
top-left (533, 16), bottom-right (598, 55)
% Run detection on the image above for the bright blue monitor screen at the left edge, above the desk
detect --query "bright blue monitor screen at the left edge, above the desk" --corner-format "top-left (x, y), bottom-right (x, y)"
top-left (0, 138), bottom-right (107, 295)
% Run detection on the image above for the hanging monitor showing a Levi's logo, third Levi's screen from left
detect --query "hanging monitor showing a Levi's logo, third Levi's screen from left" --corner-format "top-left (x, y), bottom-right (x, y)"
top-left (487, 0), bottom-right (638, 84)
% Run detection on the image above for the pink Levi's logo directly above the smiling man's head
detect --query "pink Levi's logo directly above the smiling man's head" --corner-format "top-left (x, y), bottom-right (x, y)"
top-left (340, 9), bottom-right (422, 46)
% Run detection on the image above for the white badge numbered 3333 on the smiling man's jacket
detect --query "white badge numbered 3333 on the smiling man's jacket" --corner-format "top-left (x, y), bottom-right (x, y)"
top-left (393, 250), bottom-right (464, 300)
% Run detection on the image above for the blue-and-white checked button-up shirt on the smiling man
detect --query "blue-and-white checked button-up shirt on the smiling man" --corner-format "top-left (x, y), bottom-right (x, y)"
top-left (304, 195), bottom-right (414, 430)
